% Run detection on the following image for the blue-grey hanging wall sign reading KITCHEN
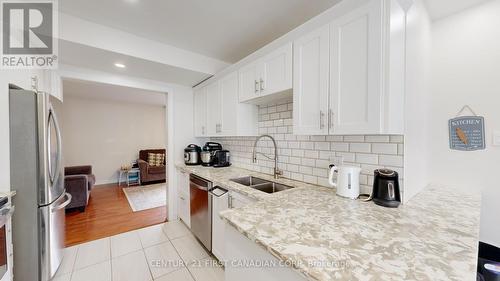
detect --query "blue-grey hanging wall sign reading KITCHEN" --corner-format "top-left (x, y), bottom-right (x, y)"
top-left (448, 116), bottom-right (486, 151)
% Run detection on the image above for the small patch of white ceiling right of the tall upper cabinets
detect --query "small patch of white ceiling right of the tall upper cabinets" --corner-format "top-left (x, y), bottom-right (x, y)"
top-left (424, 0), bottom-right (490, 20)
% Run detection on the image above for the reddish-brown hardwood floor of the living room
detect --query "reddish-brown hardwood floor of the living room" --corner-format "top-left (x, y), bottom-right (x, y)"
top-left (65, 184), bottom-right (167, 247)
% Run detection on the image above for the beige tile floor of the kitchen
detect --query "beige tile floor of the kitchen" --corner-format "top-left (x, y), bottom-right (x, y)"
top-left (53, 221), bottom-right (224, 281)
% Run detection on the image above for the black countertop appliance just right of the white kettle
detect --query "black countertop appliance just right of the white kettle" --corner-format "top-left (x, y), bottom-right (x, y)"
top-left (371, 169), bottom-right (401, 208)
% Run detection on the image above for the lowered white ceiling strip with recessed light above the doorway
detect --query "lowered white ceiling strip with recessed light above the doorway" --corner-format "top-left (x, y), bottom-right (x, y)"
top-left (59, 40), bottom-right (209, 87)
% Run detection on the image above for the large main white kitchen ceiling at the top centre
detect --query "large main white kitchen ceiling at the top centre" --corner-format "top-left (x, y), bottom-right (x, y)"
top-left (59, 0), bottom-right (340, 63)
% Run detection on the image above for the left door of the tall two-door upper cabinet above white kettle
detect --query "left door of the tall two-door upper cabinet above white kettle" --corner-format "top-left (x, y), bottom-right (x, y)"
top-left (293, 25), bottom-right (330, 135)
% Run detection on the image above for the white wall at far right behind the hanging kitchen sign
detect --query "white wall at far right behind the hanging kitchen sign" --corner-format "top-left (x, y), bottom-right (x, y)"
top-left (428, 0), bottom-right (500, 247)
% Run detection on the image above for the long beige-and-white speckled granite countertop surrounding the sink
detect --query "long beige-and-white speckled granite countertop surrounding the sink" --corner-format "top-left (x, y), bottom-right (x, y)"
top-left (175, 165), bottom-right (481, 280)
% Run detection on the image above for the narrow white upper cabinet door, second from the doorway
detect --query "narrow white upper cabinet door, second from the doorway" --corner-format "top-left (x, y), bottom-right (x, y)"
top-left (205, 81), bottom-right (222, 136)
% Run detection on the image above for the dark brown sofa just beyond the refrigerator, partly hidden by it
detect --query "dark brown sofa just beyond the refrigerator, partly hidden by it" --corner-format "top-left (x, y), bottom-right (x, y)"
top-left (64, 166), bottom-right (95, 212)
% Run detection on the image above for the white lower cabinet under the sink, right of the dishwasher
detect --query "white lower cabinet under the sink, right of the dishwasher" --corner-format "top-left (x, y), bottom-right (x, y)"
top-left (212, 191), bottom-right (256, 261)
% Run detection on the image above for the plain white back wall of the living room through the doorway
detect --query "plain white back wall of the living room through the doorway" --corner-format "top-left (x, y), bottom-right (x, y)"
top-left (58, 96), bottom-right (168, 184)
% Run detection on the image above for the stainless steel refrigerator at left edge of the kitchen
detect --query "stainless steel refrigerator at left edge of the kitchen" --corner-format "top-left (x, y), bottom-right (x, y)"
top-left (9, 85), bottom-right (71, 281)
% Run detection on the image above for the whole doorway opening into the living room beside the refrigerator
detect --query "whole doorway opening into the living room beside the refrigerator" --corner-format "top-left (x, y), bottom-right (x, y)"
top-left (55, 79), bottom-right (169, 247)
